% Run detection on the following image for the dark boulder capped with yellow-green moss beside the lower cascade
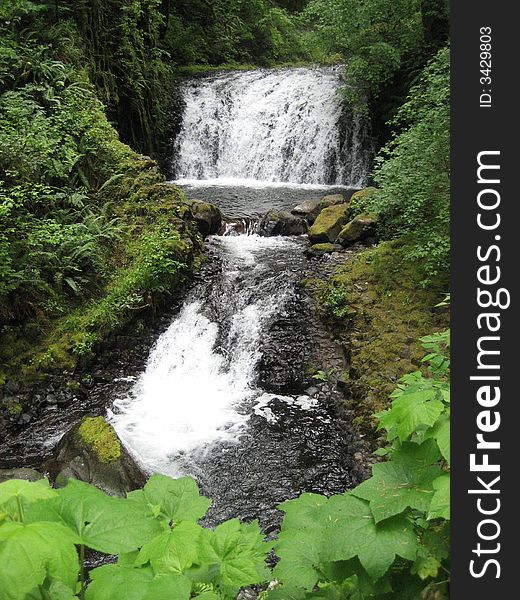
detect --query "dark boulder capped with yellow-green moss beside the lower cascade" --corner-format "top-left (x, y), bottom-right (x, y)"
top-left (43, 417), bottom-right (146, 496)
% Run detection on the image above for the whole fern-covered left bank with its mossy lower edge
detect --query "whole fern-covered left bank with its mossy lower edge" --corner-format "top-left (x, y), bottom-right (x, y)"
top-left (0, 0), bottom-right (199, 383)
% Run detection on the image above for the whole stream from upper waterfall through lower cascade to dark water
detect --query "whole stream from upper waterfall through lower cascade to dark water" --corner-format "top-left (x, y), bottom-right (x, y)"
top-left (1, 67), bottom-right (370, 532)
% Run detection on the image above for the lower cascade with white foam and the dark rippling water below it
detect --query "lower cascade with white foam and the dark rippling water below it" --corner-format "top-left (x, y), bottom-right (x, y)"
top-left (109, 234), bottom-right (362, 529)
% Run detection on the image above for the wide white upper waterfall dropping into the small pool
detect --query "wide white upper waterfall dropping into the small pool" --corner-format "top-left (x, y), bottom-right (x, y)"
top-left (172, 67), bottom-right (370, 187)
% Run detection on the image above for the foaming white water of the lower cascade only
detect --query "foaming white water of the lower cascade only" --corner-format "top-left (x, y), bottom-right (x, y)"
top-left (109, 235), bottom-right (302, 475)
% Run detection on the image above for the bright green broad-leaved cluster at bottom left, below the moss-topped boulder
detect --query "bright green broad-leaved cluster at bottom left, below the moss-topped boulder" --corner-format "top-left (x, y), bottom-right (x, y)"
top-left (0, 475), bottom-right (269, 600)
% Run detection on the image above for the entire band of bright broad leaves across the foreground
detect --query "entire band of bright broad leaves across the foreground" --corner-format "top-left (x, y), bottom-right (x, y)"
top-left (0, 332), bottom-right (450, 600)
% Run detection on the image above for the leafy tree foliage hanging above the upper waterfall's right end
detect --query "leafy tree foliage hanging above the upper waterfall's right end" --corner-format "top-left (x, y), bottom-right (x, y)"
top-left (304, 0), bottom-right (449, 109)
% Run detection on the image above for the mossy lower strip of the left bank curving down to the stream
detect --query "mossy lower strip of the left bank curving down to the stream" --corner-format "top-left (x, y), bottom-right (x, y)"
top-left (0, 154), bottom-right (202, 383)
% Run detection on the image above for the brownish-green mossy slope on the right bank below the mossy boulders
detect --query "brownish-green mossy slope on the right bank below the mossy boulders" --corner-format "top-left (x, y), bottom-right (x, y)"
top-left (319, 240), bottom-right (449, 438)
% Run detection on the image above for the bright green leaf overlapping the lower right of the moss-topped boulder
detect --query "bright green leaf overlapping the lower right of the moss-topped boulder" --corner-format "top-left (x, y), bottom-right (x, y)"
top-left (143, 474), bottom-right (211, 522)
